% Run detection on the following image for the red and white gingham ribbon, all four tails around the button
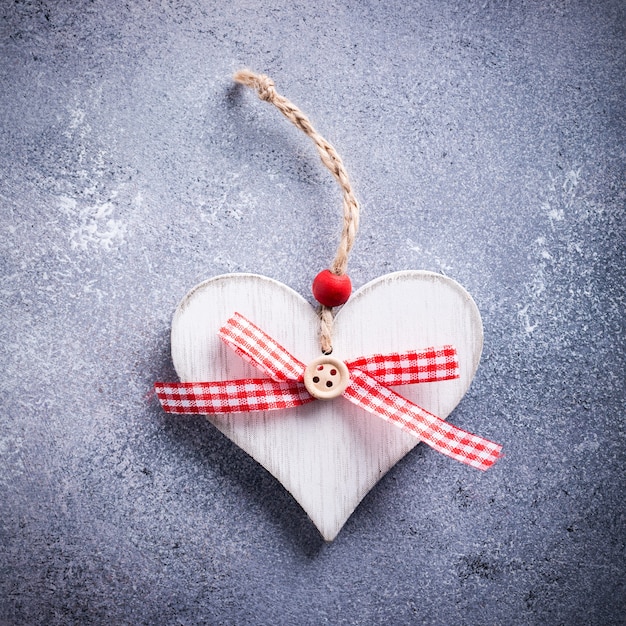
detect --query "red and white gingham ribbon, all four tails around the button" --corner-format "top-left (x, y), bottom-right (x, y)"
top-left (154, 313), bottom-right (502, 470)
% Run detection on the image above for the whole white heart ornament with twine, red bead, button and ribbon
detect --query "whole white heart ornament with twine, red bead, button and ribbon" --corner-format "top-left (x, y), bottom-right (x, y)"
top-left (155, 70), bottom-right (501, 541)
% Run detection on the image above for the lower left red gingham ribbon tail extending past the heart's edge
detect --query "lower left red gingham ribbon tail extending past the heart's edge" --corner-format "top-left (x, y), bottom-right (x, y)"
top-left (154, 378), bottom-right (314, 415)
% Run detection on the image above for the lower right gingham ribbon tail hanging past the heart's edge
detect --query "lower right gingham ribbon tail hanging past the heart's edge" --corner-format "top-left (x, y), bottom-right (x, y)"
top-left (343, 370), bottom-right (502, 470)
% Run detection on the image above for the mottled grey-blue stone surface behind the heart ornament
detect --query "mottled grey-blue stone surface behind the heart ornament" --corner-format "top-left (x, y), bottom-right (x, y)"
top-left (0, 0), bottom-right (626, 625)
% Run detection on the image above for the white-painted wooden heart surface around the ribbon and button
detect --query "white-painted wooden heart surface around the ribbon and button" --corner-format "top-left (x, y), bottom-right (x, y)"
top-left (172, 271), bottom-right (483, 541)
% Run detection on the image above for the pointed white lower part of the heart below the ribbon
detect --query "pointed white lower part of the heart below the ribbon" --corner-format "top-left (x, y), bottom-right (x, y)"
top-left (208, 398), bottom-right (417, 541)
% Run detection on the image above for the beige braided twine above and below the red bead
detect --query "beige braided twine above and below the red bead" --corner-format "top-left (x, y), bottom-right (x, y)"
top-left (233, 70), bottom-right (359, 354)
